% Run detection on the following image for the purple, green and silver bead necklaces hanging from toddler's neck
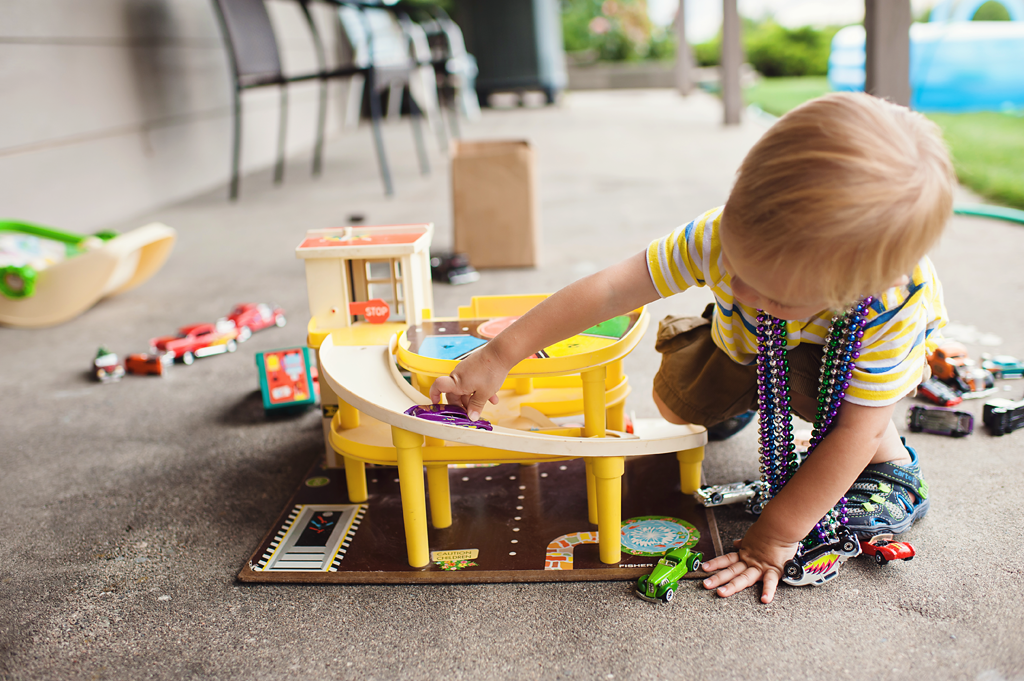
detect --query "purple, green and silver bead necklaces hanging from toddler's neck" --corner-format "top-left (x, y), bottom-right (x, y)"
top-left (757, 296), bottom-right (874, 543)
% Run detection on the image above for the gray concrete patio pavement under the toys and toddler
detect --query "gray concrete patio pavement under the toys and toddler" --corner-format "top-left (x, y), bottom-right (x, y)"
top-left (0, 91), bottom-right (1024, 681)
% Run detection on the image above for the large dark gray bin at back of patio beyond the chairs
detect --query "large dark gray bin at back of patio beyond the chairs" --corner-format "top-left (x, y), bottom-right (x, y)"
top-left (458, 0), bottom-right (568, 104)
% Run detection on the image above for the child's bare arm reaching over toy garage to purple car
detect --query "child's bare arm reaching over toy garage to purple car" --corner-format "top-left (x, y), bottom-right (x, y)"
top-left (430, 251), bottom-right (659, 413)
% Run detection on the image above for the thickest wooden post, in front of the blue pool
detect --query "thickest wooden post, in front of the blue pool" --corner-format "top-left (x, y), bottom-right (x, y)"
top-left (864, 0), bottom-right (911, 107)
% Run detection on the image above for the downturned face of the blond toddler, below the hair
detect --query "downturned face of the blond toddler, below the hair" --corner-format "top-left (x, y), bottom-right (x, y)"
top-left (720, 223), bottom-right (828, 321)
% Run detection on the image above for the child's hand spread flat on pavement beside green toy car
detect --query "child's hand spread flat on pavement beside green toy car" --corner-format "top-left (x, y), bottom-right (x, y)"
top-left (703, 522), bottom-right (798, 603)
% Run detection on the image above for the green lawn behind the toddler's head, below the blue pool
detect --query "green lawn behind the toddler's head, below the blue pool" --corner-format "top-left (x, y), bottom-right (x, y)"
top-left (744, 76), bottom-right (1024, 209)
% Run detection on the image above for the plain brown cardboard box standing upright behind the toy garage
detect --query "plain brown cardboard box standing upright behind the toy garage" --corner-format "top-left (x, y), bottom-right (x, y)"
top-left (452, 140), bottom-right (541, 269)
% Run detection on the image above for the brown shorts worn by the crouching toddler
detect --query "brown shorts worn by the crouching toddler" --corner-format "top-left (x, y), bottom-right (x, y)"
top-left (654, 304), bottom-right (823, 426)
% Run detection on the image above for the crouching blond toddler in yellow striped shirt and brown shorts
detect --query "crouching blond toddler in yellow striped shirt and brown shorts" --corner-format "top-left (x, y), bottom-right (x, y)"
top-left (430, 93), bottom-right (954, 603)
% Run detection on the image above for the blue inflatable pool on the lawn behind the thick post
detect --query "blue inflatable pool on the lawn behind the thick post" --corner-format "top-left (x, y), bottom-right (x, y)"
top-left (828, 0), bottom-right (1024, 113)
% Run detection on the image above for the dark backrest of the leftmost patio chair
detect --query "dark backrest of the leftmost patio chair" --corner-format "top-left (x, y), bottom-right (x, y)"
top-left (213, 0), bottom-right (282, 86)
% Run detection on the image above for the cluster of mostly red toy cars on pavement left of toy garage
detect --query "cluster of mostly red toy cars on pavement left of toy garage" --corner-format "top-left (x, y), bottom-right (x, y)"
top-left (91, 303), bottom-right (286, 383)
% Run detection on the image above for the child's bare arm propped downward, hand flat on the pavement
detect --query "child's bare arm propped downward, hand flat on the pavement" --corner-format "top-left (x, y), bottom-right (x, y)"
top-left (703, 402), bottom-right (895, 603)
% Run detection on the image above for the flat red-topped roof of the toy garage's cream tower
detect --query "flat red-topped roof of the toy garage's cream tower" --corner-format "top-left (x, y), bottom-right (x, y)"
top-left (295, 223), bottom-right (434, 259)
